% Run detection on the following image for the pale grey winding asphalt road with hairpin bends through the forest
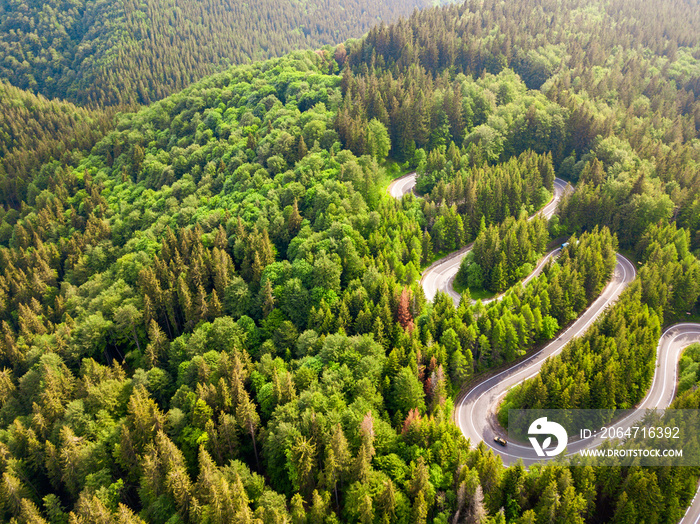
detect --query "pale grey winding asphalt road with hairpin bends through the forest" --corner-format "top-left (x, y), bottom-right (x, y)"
top-left (389, 173), bottom-right (700, 524)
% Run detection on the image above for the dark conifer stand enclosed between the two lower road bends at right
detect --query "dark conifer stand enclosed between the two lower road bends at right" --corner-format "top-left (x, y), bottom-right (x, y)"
top-left (502, 224), bottom-right (700, 418)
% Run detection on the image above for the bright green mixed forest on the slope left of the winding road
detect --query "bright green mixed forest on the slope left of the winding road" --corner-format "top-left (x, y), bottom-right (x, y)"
top-left (0, 53), bottom-right (614, 522)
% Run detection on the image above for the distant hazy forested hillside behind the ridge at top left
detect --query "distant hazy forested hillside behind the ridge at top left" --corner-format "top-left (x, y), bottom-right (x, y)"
top-left (0, 0), bottom-right (448, 107)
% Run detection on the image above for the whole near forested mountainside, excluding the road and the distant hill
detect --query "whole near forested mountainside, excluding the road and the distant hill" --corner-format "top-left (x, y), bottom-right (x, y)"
top-left (0, 0), bottom-right (700, 524)
